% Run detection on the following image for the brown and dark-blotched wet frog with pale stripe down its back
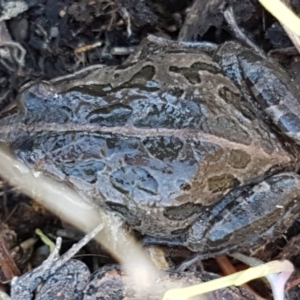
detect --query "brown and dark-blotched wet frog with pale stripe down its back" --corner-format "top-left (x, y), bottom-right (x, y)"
top-left (0, 37), bottom-right (300, 253)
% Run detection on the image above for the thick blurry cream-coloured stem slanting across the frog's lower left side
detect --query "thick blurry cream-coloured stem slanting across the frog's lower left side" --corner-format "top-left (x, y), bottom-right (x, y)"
top-left (0, 151), bottom-right (159, 292)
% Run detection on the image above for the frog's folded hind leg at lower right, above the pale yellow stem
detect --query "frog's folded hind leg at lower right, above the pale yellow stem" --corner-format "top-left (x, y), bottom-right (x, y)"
top-left (183, 173), bottom-right (300, 257)
